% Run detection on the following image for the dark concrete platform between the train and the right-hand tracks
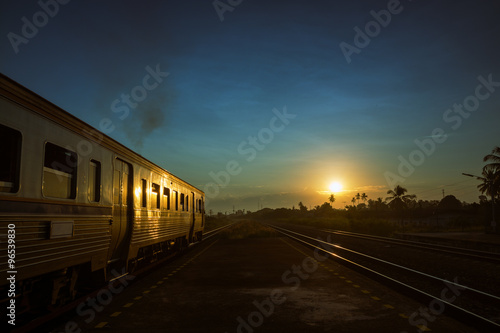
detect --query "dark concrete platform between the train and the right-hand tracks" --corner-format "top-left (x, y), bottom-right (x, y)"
top-left (51, 237), bottom-right (477, 333)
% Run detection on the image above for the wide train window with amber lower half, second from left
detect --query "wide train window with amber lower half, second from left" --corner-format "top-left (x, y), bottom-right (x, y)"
top-left (42, 142), bottom-right (78, 199)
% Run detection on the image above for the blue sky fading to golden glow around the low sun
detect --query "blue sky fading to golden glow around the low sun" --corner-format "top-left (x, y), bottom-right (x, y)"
top-left (0, 0), bottom-right (500, 213)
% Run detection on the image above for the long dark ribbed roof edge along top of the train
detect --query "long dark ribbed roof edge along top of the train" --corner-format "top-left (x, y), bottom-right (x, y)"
top-left (0, 73), bottom-right (203, 193)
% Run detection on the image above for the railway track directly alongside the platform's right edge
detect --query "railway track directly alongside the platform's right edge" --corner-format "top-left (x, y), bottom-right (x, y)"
top-left (268, 225), bottom-right (500, 332)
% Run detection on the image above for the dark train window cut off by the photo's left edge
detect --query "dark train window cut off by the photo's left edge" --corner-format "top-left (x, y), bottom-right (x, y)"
top-left (0, 124), bottom-right (22, 193)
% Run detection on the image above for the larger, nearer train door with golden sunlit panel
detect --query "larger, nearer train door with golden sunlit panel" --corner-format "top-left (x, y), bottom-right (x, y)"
top-left (108, 158), bottom-right (133, 264)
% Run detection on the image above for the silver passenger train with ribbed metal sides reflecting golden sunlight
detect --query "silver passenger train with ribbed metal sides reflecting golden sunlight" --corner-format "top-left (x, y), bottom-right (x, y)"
top-left (0, 74), bottom-right (205, 311)
